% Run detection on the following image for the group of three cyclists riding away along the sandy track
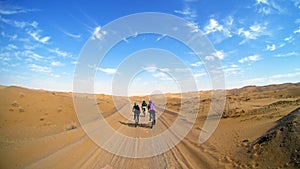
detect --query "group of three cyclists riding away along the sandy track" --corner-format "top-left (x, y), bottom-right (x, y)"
top-left (132, 100), bottom-right (156, 128)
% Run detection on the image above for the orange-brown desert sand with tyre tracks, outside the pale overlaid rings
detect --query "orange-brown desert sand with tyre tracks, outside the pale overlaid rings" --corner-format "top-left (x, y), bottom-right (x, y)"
top-left (0, 83), bottom-right (300, 169)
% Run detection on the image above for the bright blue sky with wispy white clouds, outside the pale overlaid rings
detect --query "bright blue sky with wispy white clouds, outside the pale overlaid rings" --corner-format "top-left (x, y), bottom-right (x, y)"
top-left (0, 0), bottom-right (300, 94)
